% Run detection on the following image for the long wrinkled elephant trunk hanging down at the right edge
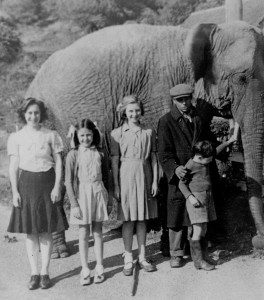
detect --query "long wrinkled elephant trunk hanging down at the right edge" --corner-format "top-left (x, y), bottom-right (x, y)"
top-left (238, 82), bottom-right (264, 239)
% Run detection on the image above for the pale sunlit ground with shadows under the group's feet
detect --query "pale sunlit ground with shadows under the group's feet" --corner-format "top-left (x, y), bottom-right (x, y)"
top-left (0, 199), bottom-right (264, 300)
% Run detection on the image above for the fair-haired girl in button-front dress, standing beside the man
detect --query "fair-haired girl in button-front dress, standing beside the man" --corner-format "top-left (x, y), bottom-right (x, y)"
top-left (111, 95), bottom-right (157, 276)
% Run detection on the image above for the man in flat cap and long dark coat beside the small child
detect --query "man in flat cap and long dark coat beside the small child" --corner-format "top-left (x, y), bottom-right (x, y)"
top-left (158, 84), bottom-right (208, 268)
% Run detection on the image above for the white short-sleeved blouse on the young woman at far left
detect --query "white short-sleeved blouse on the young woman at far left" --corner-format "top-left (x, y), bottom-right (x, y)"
top-left (7, 127), bottom-right (63, 172)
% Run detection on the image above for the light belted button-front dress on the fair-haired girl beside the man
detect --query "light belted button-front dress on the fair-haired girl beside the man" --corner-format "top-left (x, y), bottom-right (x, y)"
top-left (111, 123), bottom-right (157, 221)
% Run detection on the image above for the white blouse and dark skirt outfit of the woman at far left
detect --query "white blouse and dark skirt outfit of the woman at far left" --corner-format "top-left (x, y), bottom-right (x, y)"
top-left (7, 127), bottom-right (68, 234)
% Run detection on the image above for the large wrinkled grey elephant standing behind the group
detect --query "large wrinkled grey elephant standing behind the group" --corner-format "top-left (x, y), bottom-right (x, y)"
top-left (26, 21), bottom-right (264, 247)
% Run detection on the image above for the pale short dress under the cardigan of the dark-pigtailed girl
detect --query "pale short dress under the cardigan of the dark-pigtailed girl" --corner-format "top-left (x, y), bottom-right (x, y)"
top-left (70, 146), bottom-right (108, 225)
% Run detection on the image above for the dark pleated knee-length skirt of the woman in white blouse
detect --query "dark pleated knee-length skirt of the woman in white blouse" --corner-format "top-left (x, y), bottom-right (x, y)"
top-left (7, 168), bottom-right (69, 234)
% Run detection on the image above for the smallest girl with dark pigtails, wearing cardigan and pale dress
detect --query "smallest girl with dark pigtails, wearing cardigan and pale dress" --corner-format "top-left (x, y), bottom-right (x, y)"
top-left (65, 119), bottom-right (108, 285)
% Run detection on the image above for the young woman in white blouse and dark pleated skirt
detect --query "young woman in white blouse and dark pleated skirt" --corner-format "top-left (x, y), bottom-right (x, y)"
top-left (7, 98), bottom-right (68, 290)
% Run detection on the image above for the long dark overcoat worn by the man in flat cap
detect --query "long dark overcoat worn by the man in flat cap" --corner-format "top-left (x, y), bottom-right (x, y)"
top-left (158, 105), bottom-right (207, 230)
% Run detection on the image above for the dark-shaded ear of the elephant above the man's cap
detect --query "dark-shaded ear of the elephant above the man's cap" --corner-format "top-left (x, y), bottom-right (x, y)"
top-left (184, 23), bottom-right (218, 81)
